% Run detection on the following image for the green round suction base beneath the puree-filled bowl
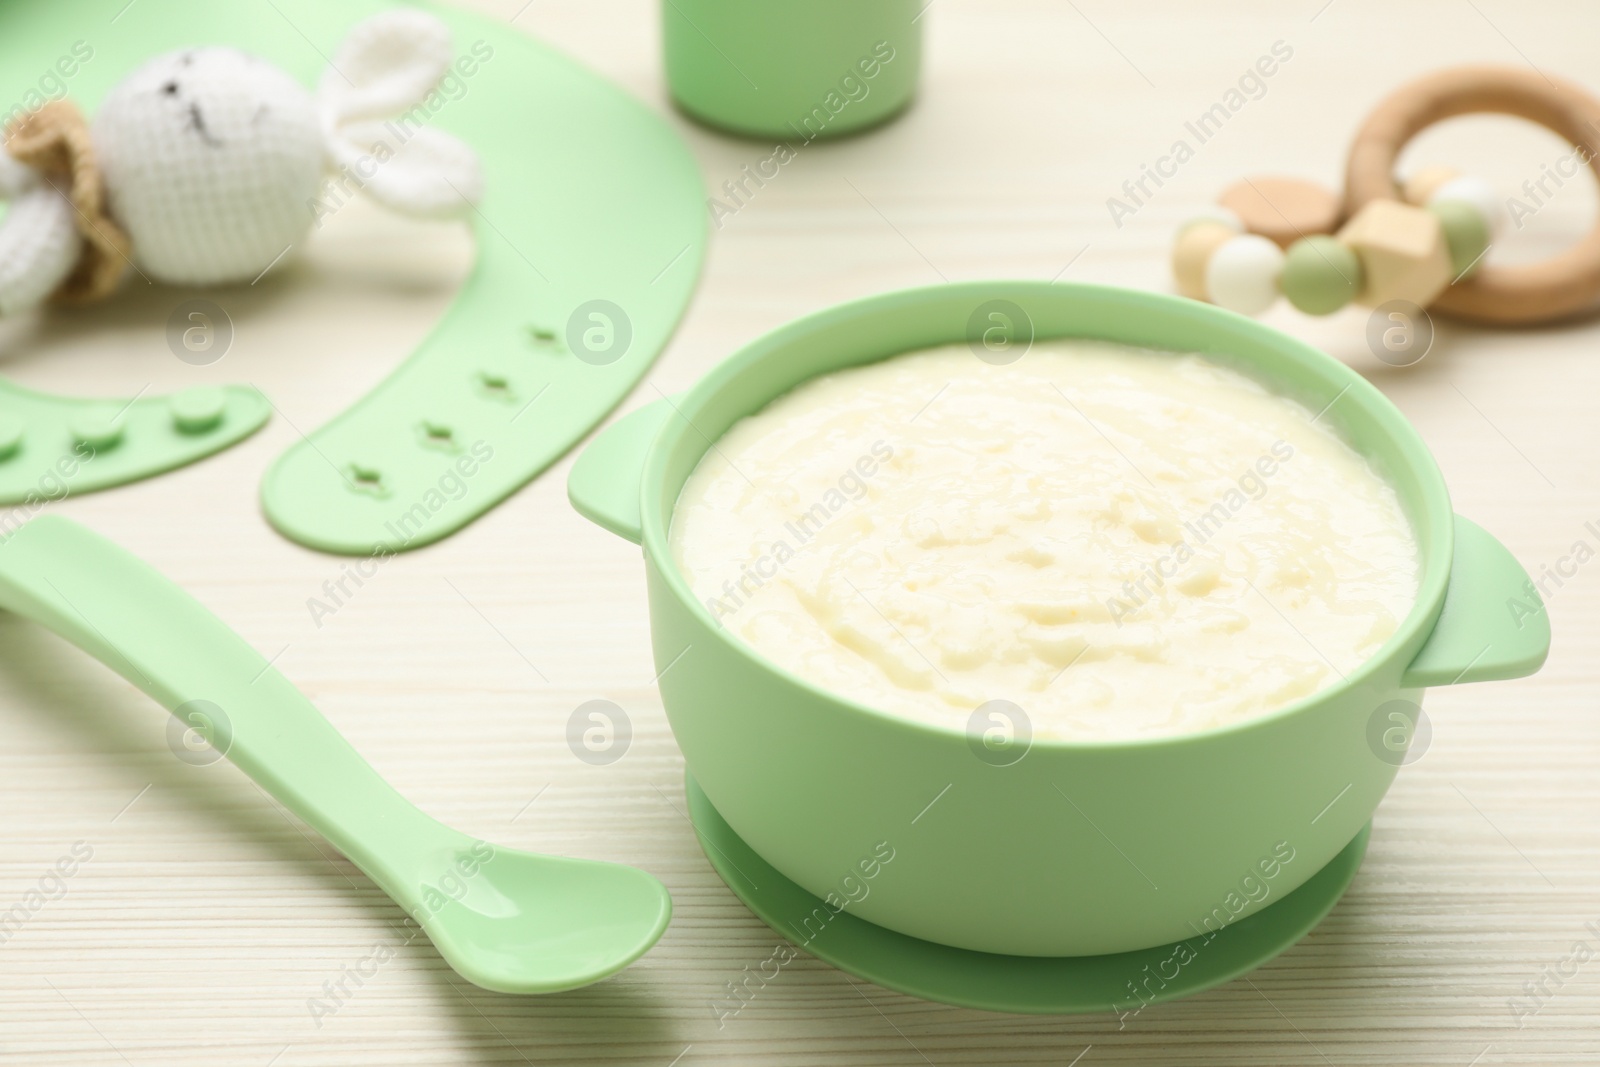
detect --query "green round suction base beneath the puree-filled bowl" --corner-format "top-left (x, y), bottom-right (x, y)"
top-left (685, 774), bottom-right (1373, 1014)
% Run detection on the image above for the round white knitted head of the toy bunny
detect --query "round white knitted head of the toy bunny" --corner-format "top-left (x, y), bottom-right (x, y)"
top-left (91, 48), bottom-right (323, 285)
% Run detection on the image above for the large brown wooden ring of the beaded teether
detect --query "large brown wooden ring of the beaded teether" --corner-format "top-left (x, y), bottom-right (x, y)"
top-left (1344, 67), bottom-right (1600, 323)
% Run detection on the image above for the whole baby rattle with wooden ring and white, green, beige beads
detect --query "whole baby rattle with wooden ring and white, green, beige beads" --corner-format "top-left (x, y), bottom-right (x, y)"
top-left (1173, 67), bottom-right (1600, 325)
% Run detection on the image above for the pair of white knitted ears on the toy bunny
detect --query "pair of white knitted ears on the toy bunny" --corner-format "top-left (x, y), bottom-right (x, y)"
top-left (317, 8), bottom-right (483, 218)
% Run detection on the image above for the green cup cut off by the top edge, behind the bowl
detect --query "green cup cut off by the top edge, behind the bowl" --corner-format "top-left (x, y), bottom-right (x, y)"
top-left (661, 0), bottom-right (922, 146)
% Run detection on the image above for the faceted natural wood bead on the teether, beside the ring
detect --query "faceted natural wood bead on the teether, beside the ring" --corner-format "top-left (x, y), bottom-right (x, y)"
top-left (1339, 200), bottom-right (1454, 307)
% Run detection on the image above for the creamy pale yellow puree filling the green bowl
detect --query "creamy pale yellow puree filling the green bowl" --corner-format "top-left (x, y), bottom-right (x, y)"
top-left (670, 341), bottom-right (1419, 739)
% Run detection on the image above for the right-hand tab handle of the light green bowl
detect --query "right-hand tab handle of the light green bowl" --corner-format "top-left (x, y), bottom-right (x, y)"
top-left (1400, 515), bottom-right (1550, 689)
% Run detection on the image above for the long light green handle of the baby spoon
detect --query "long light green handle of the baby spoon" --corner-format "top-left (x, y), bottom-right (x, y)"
top-left (0, 515), bottom-right (438, 894)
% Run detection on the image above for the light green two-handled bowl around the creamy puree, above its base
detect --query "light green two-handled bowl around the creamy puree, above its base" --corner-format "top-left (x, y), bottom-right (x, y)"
top-left (568, 282), bottom-right (1550, 957)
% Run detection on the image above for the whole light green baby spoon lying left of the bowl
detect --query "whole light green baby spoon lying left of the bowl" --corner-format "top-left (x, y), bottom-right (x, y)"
top-left (0, 515), bottom-right (672, 993)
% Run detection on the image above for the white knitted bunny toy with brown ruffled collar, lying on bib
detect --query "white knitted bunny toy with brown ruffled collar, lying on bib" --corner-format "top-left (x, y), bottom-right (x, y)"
top-left (0, 8), bottom-right (483, 315)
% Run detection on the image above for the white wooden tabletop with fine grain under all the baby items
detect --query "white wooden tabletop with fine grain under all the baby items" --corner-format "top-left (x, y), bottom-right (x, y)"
top-left (0, 0), bottom-right (1600, 1067)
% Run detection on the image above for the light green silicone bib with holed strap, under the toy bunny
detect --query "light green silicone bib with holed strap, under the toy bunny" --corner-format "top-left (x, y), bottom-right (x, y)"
top-left (0, 0), bottom-right (706, 553)
